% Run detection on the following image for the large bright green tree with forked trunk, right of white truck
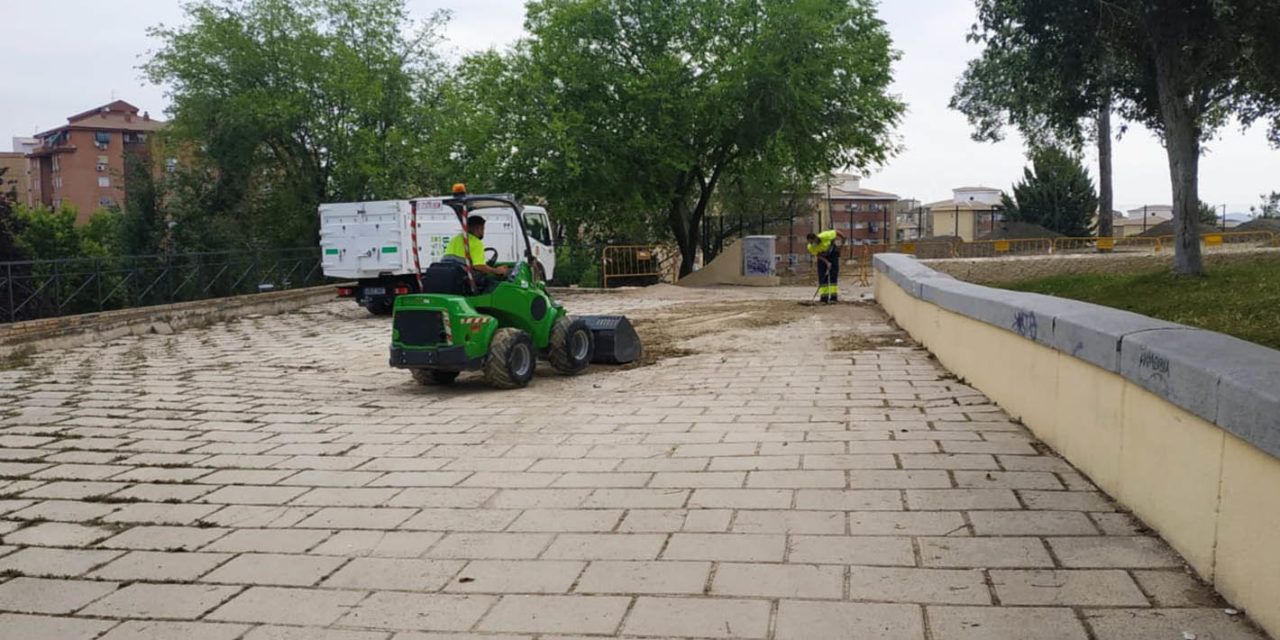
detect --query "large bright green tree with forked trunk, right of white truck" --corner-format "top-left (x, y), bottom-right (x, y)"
top-left (526, 0), bottom-right (902, 274)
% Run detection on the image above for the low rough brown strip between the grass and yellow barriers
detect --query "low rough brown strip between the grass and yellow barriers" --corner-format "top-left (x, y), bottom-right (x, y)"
top-left (922, 248), bottom-right (1280, 284)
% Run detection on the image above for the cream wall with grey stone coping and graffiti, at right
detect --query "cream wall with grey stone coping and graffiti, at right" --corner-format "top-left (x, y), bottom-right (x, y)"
top-left (876, 253), bottom-right (1280, 636)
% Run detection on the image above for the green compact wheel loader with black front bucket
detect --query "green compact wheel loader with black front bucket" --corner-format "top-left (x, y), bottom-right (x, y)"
top-left (390, 184), bottom-right (641, 389)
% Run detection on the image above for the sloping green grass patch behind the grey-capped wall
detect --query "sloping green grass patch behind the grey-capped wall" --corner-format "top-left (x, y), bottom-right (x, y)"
top-left (1005, 257), bottom-right (1280, 349)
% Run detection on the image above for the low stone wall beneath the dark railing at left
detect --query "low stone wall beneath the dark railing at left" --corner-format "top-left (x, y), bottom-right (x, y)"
top-left (0, 285), bottom-right (335, 358)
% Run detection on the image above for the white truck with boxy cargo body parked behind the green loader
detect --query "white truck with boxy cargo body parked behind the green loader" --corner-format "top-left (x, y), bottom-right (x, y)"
top-left (320, 197), bottom-right (556, 315)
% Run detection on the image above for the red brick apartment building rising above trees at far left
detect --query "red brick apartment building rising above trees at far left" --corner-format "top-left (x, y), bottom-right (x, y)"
top-left (27, 100), bottom-right (164, 223)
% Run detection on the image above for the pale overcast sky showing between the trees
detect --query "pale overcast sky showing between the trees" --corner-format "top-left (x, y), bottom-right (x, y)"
top-left (0, 0), bottom-right (1280, 211)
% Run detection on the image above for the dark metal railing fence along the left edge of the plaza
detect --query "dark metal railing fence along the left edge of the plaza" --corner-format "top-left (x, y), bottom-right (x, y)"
top-left (0, 247), bottom-right (324, 324)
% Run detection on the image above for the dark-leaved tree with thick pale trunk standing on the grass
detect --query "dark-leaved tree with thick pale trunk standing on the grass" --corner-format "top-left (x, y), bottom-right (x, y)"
top-left (957, 0), bottom-right (1280, 275)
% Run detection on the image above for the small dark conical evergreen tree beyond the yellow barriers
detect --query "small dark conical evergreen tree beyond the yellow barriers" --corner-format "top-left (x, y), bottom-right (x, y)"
top-left (1002, 146), bottom-right (1098, 238)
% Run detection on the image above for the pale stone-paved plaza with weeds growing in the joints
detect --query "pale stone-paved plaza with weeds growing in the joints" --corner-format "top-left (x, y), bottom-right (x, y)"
top-left (0, 287), bottom-right (1265, 640)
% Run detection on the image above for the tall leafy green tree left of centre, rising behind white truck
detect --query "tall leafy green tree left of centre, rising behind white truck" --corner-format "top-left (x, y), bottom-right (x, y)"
top-left (143, 0), bottom-right (443, 246)
